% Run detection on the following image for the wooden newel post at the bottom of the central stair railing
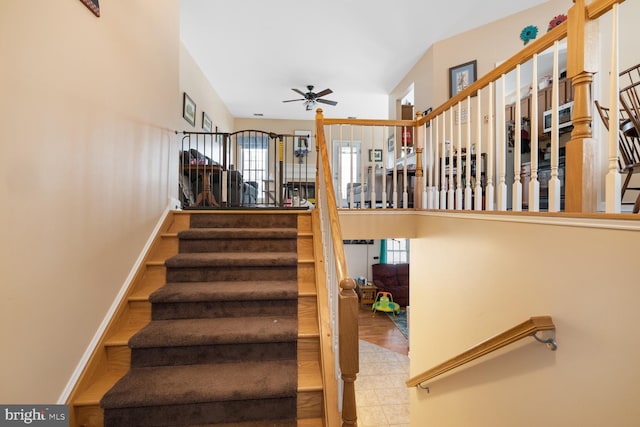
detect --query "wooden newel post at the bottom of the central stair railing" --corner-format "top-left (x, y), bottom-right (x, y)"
top-left (338, 277), bottom-right (360, 427)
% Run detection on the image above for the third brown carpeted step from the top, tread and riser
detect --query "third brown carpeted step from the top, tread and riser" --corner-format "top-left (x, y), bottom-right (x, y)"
top-left (165, 252), bottom-right (298, 283)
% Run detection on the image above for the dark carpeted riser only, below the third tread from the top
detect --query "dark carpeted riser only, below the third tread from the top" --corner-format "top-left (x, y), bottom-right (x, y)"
top-left (167, 265), bottom-right (296, 282)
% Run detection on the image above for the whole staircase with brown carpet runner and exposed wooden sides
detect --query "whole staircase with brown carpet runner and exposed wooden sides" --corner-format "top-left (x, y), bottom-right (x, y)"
top-left (70, 211), bottom-right (324, 427)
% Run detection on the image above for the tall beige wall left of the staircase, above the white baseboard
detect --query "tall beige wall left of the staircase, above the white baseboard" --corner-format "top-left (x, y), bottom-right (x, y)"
top-left (0, 0), bottom-right (181, 403)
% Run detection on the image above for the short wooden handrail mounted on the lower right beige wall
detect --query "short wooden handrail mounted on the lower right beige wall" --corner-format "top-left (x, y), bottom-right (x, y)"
top-left (406, 316), bottom-right (556, 387)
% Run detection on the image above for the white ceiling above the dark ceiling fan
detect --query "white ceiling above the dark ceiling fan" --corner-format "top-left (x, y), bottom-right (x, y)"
top-left (180, 0), bottom-right (547, 120)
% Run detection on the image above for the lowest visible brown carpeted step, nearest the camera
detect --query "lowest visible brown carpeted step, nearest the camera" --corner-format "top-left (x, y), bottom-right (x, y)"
top-left (101, 360), bottom-right (297, 427)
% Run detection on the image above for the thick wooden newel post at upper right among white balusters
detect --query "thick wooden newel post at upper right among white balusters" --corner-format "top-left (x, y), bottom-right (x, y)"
top-left (565, 0), bottom-right (597, 212)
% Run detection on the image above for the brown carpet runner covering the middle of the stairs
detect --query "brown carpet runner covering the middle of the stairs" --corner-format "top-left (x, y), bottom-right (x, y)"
top-left (101, 213), bottom-right (298, 427)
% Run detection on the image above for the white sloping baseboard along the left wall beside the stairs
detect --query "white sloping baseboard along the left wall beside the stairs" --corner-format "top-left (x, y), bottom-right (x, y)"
top-left (57, 202), bottom-right (171, 405)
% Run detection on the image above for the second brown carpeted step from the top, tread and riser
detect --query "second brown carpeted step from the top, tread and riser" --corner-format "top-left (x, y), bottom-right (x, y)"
top-left (178, 228), bottom-right (298, 253)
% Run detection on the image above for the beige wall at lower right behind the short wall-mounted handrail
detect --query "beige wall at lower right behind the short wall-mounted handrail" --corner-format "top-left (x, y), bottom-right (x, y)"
top-left (410, 214), bottom-right (640, 427)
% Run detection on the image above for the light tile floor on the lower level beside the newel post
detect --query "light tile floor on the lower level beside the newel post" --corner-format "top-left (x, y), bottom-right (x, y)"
top-left (355, 340), bottom-right (409, 427)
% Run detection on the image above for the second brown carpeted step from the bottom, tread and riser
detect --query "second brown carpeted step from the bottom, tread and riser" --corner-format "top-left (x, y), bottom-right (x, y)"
top-left (129, 316), bottom-right (298, 368)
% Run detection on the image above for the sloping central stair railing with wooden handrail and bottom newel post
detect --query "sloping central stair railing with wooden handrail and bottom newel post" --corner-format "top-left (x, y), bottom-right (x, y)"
top-left (316, 109), bottom-right (359, 426)
